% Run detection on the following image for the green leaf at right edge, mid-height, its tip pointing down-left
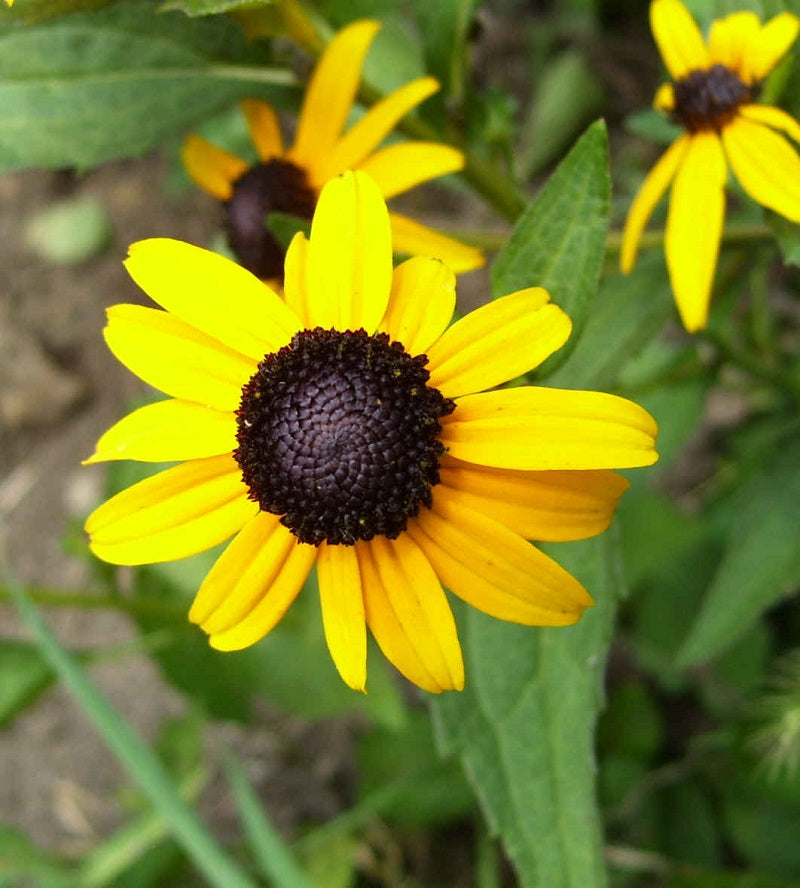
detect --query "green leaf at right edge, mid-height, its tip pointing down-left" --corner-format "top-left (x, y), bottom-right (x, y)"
top-left (678, 442), bottom-right (800, 667)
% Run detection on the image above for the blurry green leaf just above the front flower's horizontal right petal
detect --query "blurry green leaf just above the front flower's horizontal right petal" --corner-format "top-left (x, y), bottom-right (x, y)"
top-left (547, 252), bottom-right (675, 390)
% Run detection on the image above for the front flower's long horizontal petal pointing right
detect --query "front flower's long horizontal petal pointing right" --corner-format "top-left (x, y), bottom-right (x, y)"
top-left (440, 386), bottom-right (658, 471)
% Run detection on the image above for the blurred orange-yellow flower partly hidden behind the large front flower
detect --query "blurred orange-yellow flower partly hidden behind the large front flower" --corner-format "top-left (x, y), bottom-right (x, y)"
top-left (183, 20), bottom-right (484, 280)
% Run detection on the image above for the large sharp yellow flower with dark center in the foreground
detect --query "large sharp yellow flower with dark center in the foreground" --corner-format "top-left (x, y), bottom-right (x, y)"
top-left (86, 172), bottom-right (656, 691)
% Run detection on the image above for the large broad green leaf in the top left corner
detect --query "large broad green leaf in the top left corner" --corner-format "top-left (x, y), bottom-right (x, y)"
top-left (0, 0), bottom-right (294, 170)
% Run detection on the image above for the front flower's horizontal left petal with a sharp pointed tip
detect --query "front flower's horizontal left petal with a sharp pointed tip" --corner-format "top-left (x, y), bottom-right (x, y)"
top-left (83, 400), bottom-right (236, 465)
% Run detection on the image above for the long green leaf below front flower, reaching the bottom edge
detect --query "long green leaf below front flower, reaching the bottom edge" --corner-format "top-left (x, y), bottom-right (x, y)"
top-left (431, 534), bottom-right (621, 888)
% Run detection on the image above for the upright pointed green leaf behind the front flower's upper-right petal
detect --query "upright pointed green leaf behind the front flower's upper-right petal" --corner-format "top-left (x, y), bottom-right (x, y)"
top-left (492, 121), bottom-right (610, 370)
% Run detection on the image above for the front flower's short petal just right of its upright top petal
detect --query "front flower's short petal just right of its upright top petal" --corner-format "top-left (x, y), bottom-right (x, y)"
top-left (380, 257), bottom-right (456, 355)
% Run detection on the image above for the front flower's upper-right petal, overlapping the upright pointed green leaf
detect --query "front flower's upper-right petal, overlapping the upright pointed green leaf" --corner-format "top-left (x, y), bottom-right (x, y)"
top-left (428, 287), bottom-right (572, 398)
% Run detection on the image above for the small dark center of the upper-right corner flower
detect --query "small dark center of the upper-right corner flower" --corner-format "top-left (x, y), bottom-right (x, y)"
top-left (673, 65), bottom-right (759, 133)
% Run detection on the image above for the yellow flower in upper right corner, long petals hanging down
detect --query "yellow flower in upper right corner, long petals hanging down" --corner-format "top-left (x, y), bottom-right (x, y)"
top-left (621, 0), bottom-right (800, 332)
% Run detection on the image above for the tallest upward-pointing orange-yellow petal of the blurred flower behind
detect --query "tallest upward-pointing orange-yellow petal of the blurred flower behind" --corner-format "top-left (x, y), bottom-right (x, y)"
top-left (287, 20), bottom-right (380, 173)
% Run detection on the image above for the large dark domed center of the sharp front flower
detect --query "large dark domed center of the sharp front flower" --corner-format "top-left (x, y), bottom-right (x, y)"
top-left (234, 327), bottom-right (455, 545)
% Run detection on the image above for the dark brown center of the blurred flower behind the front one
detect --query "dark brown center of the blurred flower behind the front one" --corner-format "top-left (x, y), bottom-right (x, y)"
top-left (225, 158), bottom-right (317, 280)
